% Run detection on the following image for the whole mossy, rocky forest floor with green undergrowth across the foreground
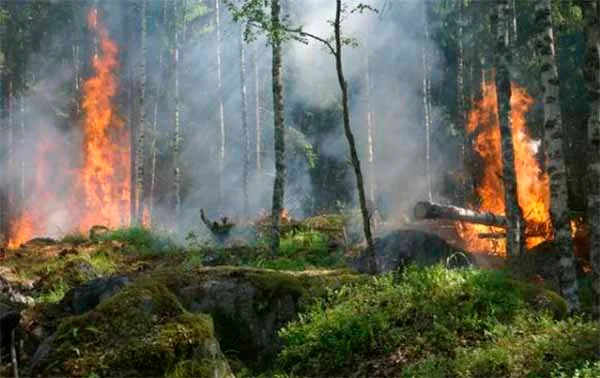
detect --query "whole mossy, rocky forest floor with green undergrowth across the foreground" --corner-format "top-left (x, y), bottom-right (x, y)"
top-left (0, 216), bottom-right (600, 378)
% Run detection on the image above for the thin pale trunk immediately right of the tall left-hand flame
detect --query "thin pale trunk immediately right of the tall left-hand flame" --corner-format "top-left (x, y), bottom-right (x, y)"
top-left (135, 0), bottom-right (147, 225)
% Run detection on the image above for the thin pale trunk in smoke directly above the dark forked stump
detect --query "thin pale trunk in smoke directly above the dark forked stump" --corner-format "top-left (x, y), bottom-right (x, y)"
top-left (215, 0), bottom-right (225, 208)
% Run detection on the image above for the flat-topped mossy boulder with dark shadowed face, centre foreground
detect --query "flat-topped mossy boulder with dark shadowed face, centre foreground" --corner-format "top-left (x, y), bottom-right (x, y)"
top-left (142, 267), bottom-right (367, 369)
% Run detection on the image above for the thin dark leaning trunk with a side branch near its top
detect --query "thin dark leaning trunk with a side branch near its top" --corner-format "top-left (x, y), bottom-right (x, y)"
top-left (333, 0), bottom-right (377, 274)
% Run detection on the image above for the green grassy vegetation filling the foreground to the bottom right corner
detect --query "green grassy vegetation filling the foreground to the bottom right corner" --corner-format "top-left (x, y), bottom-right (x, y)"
top-left (278, 266), bottom-right (600, 378)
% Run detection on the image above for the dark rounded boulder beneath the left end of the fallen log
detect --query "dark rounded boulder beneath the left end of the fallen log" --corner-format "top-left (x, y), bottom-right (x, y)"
top-left (350, 230), bottom-right (470, 273)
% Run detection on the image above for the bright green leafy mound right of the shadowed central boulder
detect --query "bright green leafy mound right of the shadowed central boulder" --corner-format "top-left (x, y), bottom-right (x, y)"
top-left (279, 266), bottom-right (580, 376)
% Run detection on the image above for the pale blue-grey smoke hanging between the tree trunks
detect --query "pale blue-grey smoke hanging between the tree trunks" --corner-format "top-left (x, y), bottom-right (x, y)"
top-left (3, 0), bottom-right (445, 242)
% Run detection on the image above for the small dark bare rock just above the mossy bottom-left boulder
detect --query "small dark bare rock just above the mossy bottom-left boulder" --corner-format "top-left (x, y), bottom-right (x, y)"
top-left (60, 276), bottom-right (129, 314)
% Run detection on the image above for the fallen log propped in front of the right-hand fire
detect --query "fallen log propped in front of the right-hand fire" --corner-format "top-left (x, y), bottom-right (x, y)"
top-left (414, 201), bottom-right (508, 228)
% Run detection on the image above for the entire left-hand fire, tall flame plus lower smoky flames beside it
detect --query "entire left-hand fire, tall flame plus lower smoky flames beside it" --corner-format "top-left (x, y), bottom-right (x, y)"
top-left (8, 9), bottom-right (131, 247)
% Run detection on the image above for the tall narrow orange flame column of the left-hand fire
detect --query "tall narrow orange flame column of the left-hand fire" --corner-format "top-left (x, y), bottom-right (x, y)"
top-left (79, 9), bottom-right (131, 230)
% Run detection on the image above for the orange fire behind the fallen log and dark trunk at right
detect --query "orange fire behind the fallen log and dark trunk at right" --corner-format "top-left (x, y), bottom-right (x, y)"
top-left (457, 82), bottom-right (552, 254)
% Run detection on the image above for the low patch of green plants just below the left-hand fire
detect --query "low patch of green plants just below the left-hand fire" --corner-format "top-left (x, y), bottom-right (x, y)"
top-left (98, 227), bottom-right (179, 256)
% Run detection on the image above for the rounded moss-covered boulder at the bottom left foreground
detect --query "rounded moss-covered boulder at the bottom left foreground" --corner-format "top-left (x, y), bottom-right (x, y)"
top-left (32, 283), bottom-right (230, 377)
